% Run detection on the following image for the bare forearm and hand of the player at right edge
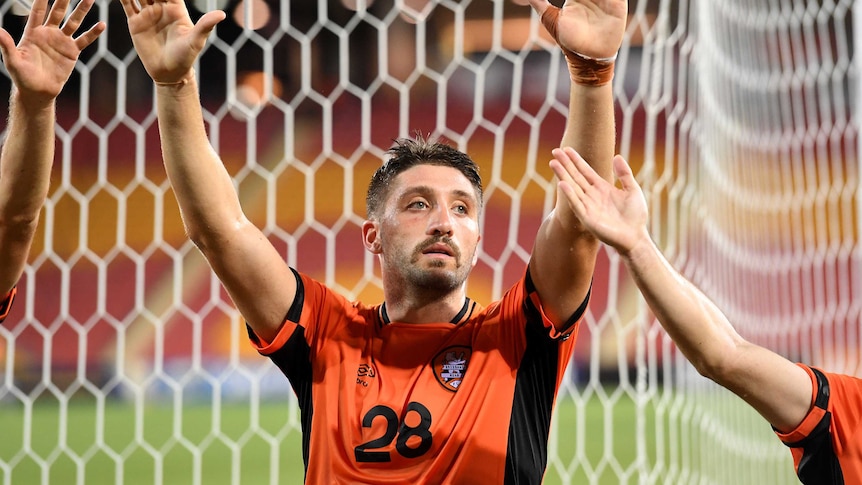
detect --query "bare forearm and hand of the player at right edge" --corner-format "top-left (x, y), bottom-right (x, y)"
top-left (556, 150), bottom-right (812, 432)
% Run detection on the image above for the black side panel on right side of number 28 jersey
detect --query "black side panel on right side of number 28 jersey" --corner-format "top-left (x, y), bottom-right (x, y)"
top-left (504, 274), bottom-right (584, 485)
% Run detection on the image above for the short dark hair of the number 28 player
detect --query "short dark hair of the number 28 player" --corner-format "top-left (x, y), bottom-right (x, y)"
top-left (365, 135), bottom-right (483, 218)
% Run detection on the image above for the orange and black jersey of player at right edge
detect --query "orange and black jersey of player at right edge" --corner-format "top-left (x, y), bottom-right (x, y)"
top-left (777, 364), bottom-right (862, 485)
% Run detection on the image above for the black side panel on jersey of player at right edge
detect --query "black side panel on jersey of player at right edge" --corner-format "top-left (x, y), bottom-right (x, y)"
top-left (785, 368), bottom-right (844, 485)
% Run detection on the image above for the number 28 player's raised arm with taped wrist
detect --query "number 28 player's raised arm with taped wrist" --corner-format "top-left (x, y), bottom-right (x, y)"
top-left (530, 0), bottom-right (628, 329)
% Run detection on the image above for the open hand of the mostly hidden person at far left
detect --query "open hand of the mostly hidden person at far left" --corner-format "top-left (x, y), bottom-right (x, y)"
top-left (0, 0), bottom-right (105, 102)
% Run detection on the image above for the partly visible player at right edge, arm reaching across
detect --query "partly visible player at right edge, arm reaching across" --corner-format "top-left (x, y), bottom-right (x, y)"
top-left (559, 152), bottom-right (862, 484)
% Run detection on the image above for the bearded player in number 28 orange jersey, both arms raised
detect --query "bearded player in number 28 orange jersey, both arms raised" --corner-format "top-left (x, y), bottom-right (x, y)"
top-left (122, 0), bottom-right (628, 478)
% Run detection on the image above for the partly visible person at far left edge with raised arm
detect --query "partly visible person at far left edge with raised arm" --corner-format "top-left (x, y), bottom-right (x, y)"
top-left (0, 0), bottom-right (105, 322)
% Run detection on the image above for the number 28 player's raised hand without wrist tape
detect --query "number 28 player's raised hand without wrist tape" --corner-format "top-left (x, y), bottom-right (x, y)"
top-left (121, 0), bottom-right (225, 84)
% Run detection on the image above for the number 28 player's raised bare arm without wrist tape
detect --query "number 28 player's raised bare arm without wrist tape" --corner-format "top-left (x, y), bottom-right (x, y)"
top-left (122, 0), bottom-right (296, 341)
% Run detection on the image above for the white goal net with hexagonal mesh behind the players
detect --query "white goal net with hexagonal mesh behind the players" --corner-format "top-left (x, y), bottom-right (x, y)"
top-left (0, 0), bottom-right (862, 485)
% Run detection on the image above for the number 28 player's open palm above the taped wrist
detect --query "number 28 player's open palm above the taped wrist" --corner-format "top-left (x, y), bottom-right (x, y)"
top-left (530, 0), bottom-right (628, 59)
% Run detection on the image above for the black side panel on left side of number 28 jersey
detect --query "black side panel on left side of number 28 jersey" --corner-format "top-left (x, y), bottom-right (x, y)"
top-left (249, 268), bottom-right (314, 471)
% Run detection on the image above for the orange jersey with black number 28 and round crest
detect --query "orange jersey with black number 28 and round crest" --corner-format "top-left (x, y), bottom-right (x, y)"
top-left (249, 273), bottom-right (586, 485)
